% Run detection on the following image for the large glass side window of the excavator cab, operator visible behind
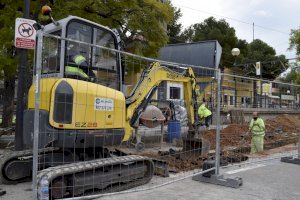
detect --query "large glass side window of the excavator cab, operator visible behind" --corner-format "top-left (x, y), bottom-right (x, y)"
top-left (65, 21), bottom-right (120, 90)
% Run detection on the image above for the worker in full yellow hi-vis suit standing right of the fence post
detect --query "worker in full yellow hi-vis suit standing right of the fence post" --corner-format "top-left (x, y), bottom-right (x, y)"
top-left (249, 112), bottom-right (265, 153)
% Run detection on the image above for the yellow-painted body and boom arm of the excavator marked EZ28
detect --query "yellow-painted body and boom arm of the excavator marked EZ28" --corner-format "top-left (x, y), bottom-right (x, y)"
top-left (28, 63), bottom-right (195, 141)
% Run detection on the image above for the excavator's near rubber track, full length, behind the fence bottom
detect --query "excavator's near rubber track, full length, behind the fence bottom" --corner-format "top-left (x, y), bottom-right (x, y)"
top-left (37, 155), bottom-right (154, 199)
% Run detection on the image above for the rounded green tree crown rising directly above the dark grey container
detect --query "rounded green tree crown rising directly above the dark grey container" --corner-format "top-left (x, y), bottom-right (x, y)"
top-left (182, 17), bottom-right (245, 67)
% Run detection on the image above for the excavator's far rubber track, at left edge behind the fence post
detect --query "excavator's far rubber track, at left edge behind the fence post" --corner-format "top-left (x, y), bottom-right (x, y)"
top-left (0, 147), bottom-right (58, 184)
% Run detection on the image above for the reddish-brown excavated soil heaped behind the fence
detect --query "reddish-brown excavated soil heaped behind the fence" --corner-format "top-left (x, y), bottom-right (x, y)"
top-left (144, 115), bottom-right (300, 172)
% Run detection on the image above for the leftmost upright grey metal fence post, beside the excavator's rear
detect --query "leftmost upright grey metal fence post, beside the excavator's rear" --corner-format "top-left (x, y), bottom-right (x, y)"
top-left (32, 30), bottom-right (43, 200)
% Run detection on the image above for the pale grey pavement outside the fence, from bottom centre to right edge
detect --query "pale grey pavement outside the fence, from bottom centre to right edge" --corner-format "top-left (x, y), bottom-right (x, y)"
top-left (99, 160), bottom-right (300, 200)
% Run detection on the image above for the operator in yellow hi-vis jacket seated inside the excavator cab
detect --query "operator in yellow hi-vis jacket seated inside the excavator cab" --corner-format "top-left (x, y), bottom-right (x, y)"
top-left (65, 54), bottom-right (96, 82)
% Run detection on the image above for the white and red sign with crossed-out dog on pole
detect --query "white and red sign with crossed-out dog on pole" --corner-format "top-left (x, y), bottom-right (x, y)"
top-left (15, 18), bottom-right (36, 49)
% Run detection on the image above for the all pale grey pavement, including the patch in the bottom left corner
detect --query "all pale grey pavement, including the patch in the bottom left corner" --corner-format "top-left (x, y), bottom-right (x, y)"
top-left (0, 145), bottom-right (300, 200)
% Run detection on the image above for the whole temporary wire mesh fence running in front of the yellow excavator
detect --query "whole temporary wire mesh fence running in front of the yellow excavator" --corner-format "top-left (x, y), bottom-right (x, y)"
top-left (29, 31), bottom-right (300, 199)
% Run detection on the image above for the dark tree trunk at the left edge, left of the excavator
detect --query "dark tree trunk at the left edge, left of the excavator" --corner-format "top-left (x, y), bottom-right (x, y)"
top-left (2, 77), bottom-right (15, 127)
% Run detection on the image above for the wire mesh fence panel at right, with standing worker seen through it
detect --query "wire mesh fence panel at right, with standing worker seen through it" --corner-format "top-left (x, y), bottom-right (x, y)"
top-left (213, 74), bottom-right (300, 165)
